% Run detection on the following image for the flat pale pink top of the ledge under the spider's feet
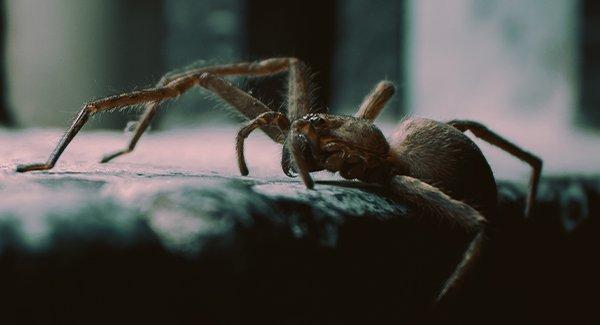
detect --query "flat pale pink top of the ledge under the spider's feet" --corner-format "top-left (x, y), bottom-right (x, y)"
top-left (0, 121), bottom-right (600, 182)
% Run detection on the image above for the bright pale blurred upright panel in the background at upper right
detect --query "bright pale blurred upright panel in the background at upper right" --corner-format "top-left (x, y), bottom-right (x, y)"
top-left (409, 0), bottom-right (577, 120)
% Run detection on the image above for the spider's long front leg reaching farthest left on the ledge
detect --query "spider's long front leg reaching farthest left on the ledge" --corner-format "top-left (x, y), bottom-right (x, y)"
top-left (17, 72), bottom-right (274, 172)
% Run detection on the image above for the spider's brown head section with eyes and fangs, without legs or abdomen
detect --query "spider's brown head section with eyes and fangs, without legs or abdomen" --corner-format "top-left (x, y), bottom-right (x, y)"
top-left (288, 113), bottom-right (389, 188)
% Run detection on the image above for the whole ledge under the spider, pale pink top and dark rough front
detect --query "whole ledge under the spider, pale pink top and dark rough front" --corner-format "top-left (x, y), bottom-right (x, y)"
top-left (0, 129), bottom-right (600, 322)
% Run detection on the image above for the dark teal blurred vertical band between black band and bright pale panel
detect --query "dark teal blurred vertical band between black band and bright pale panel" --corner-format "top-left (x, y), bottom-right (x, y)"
top-left (333, 0), bottom-right (409, 118)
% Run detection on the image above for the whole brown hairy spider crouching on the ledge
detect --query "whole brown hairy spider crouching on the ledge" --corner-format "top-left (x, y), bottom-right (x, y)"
top-left (17, 58), bottom-right (542, 300)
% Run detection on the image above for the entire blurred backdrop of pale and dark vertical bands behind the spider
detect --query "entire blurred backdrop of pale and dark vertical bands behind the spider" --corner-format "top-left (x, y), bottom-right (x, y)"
top-left (0, 0), bottom-right (600, 178)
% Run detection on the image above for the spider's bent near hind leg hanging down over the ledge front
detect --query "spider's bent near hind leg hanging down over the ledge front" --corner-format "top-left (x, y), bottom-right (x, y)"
top-left (390, 176), bottom-right (487, 302)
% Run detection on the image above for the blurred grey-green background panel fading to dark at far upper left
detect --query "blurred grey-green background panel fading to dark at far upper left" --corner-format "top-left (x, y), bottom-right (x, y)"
top-left (6, 0), bottom-right (164, 127)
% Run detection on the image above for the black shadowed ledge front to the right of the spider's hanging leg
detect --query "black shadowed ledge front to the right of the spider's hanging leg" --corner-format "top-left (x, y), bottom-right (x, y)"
top-left (442, 176), bottom-right (600, 324)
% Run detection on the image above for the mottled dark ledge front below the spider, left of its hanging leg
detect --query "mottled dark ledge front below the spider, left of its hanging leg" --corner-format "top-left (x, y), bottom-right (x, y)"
top-left (0, 178), bottom-right (474, 322)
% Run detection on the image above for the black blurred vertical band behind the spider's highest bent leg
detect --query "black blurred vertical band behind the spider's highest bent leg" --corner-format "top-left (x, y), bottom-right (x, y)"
top-left (244, 0), bottom-right (336, 113)
